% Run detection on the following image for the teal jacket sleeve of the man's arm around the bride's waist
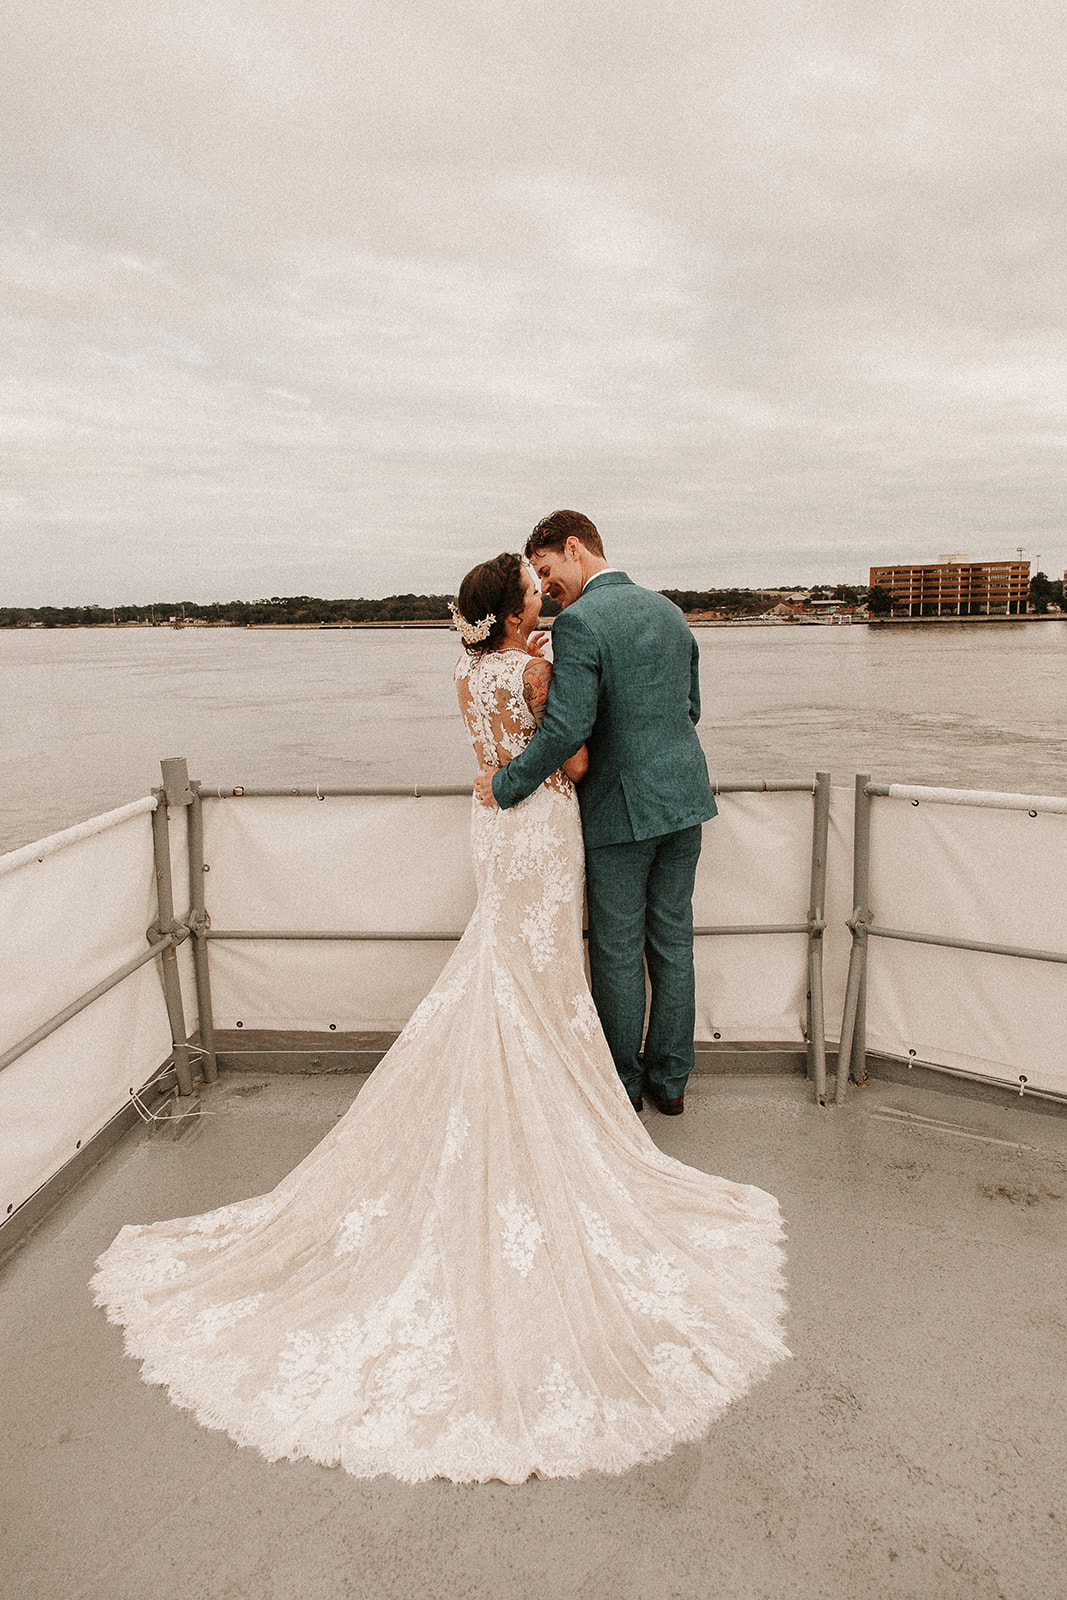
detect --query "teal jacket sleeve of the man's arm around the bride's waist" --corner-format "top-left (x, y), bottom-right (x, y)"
top-left (493, 611), bottom-right (600, 811)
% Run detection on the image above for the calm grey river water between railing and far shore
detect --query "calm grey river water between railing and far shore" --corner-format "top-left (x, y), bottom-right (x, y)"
top-left (0, 619), bottom-right (1067, 851)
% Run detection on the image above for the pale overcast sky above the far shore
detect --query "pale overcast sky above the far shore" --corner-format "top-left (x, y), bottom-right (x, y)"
top-left (0, 0), bottom-right (1067, 605)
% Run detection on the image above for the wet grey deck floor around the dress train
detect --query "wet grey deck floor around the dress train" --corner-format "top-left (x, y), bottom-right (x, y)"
top-left (0, 1074), bottom-right (1067, 1600)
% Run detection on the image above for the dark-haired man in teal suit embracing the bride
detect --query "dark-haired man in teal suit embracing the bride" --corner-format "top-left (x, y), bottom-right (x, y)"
top-left (475, 510), bottom-right (715, 1117)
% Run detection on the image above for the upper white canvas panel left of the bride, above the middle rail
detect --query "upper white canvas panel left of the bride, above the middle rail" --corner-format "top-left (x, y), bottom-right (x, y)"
top-left (205, 795), bottom-right (475, 934)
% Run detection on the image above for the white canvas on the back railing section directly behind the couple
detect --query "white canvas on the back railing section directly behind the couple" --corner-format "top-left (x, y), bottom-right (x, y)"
top-left (198, 792), bottom-right (831, 1040)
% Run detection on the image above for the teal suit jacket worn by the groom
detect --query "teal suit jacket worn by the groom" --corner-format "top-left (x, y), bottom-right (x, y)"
top-left (493, 571), bottom-right (715, 848)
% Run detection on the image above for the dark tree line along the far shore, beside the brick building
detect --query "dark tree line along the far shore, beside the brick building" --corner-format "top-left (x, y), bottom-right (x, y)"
top-left (0, 573), bottom-right (1064, 627)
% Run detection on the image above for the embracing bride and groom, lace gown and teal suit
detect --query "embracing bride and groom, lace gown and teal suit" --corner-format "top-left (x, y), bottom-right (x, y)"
top-left (94, 512), bottom-right (787, 1483)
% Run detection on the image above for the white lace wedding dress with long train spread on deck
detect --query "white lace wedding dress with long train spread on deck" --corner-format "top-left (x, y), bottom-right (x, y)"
top-left (93, 651), bottom-right (787, 1483)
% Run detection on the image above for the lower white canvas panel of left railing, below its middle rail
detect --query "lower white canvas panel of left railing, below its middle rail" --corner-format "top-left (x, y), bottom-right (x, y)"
top-left (0, 960), bottom-right (171, 1216)
